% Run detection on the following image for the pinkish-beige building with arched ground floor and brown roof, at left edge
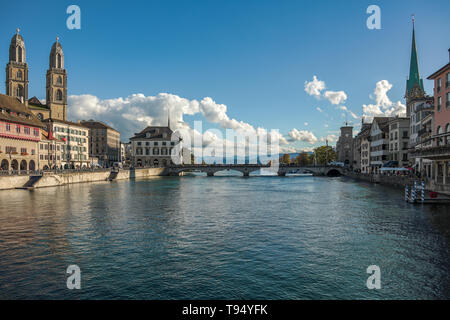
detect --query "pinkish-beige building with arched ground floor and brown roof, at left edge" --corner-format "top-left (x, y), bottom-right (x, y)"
top-left (0, 94), bottom-right (43, 171)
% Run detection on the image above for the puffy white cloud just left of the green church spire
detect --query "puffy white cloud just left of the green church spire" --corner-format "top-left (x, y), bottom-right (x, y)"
top-left (363, 80), bottom-right (406, 121)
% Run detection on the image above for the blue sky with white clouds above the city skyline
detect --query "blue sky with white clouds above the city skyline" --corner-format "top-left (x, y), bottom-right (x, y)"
top-left (0, 0), bottom-right (450, 152)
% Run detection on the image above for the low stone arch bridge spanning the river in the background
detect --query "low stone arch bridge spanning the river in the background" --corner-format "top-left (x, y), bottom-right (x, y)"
top-left (167, 164), bottom-right (344, 177)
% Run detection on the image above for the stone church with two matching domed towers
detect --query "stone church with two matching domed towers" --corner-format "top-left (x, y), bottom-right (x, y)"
top-left (6, 29), bottom-right (67, 121)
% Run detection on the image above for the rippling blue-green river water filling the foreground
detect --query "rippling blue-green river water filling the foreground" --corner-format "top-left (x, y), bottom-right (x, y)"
top-left (0, 176), bottom-right (450, 299)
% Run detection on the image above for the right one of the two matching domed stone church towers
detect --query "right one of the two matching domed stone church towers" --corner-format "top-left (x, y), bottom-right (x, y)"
top-left (46, 38), bottom-right (67, 120)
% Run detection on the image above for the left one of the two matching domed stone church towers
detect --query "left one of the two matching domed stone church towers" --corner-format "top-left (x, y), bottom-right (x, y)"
top-left (6, 29), bottom-right (28, 104)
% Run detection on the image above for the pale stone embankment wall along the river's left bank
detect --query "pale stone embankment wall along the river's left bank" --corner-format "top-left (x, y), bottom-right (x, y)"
top-left (0, 168), bottom-right (167, 190)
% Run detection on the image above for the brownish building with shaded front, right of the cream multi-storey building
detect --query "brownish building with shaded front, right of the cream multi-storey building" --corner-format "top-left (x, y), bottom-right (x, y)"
top-left (80, 120), bottom-right (121, 167)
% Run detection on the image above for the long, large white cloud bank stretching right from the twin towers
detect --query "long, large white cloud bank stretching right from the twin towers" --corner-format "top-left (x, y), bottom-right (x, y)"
top-left (68, 93), bottom-right (296, 157)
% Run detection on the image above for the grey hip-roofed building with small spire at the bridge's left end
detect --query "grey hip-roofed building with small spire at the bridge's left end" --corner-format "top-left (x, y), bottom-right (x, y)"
top-left (130, 126), bottom-right (182, 167)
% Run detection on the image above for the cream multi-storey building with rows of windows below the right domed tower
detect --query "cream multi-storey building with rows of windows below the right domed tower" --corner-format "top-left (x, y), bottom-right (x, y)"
top-left (44, 119), bottom-right (91, 169)
